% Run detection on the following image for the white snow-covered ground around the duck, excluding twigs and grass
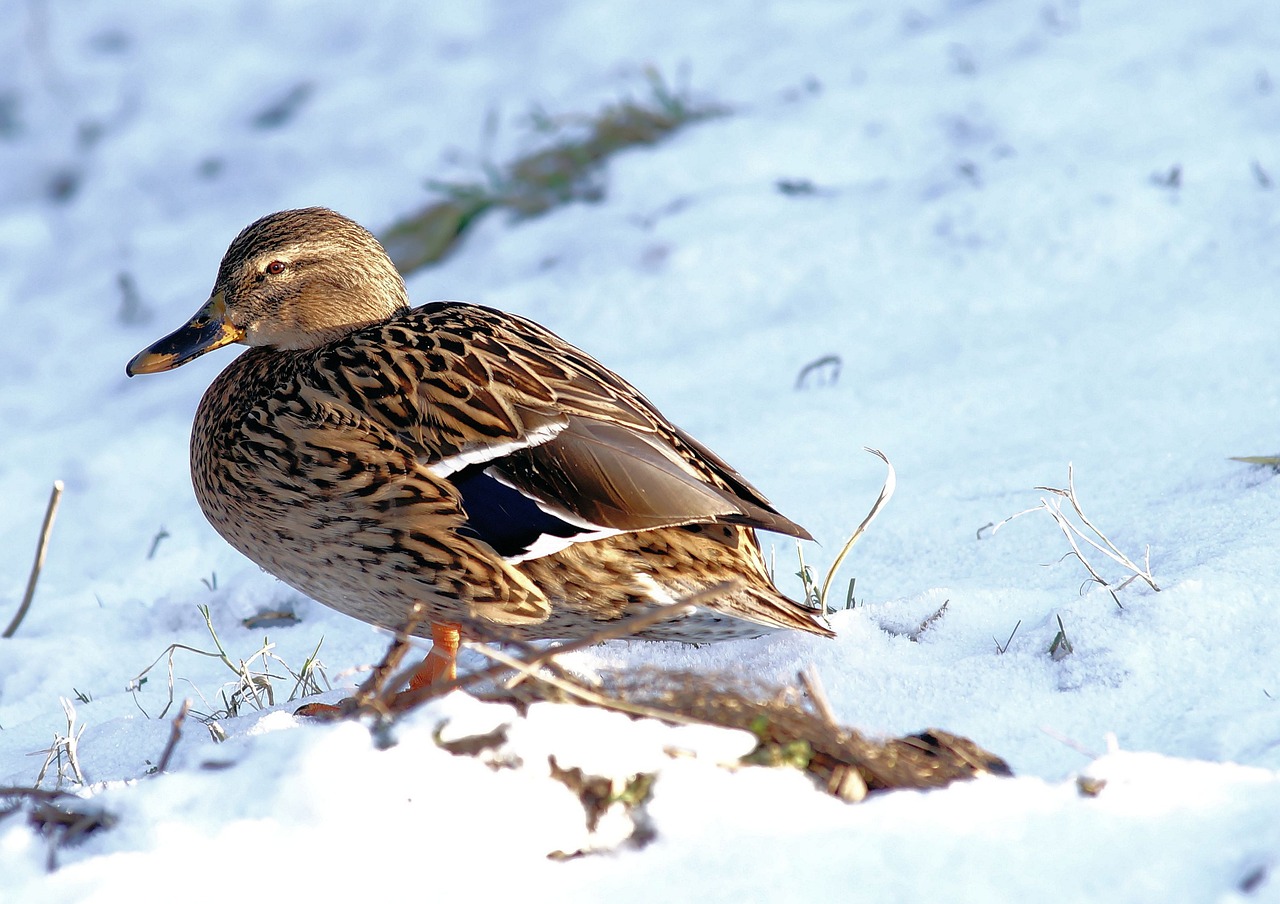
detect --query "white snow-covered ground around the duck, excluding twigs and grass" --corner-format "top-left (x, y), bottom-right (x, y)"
top-left (0, 0), bottom-right (1280, 901)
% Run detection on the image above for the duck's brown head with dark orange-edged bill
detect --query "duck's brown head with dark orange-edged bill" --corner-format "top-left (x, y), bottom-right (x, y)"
top-left (125, 207), bottom-right (408, 376)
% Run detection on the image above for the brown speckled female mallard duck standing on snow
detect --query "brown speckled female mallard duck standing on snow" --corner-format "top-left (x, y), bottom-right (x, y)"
top-left (127, 207), bottom-right (832, 680)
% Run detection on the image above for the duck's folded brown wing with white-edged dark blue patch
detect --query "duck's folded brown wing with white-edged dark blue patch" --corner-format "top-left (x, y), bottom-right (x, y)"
top-left (309, 303), bottom-right (809, 560)
